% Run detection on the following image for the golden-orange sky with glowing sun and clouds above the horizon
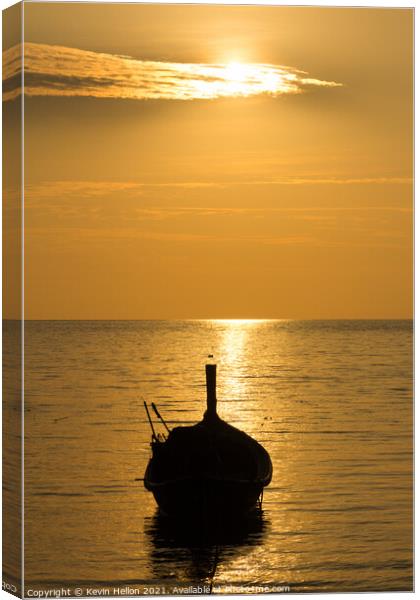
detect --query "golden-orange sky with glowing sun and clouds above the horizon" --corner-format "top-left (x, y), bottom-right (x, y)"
top-left (4, 3), bottom-right (413, 319)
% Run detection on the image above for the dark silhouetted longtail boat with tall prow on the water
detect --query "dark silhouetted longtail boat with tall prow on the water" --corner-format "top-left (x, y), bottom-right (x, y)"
top-left (144, 364), bottom-right (273, 518)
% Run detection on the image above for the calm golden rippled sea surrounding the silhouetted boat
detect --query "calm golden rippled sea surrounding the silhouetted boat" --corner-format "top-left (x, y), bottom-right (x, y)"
top-left (17, 321), bottom-right (412, 593)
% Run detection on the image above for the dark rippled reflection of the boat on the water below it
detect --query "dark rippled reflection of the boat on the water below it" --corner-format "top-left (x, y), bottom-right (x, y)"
top-left (144, 511), bottom-right (270, 593)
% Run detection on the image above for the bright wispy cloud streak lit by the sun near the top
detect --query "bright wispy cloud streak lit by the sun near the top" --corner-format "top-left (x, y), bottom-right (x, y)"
top-left (3, 43), bottom-right (342, 100)
